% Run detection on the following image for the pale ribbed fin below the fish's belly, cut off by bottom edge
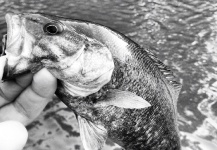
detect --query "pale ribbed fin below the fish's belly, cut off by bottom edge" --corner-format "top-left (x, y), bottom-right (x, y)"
top-left (77, 116), bottom-right (107, 150)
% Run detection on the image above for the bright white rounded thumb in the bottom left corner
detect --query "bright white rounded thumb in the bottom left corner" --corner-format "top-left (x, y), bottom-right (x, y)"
top-left (0, 121), bottom-right (28, 150)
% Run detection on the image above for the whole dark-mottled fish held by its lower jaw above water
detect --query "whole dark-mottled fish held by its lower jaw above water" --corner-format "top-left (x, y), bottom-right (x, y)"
top-left (2, 13), bottom-right (181, 150)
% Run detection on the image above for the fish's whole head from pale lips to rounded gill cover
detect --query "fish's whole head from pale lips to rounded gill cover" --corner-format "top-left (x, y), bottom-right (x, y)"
top-left (3, 14), bottom-right (114, 95)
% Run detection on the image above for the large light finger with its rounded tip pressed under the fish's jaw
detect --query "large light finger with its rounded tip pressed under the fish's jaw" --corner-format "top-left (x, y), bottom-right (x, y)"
top-left (0, 69), bottom-right (57, 125)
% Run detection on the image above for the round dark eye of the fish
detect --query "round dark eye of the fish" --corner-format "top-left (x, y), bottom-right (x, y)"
top-left (43, 22), bottom-right (63, 35)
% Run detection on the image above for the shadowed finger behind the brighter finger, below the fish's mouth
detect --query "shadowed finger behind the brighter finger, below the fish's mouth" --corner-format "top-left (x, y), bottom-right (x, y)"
top-left (0, 73), bottom-right (33, 107)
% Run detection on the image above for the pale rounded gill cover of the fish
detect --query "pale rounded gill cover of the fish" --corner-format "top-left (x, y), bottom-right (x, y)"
top-left (58, 41), bottom-right (114, 97)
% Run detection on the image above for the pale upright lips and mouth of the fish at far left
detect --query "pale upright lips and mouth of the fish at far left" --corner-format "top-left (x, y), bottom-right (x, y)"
top-left (0, 13), bottom-right (28, 80)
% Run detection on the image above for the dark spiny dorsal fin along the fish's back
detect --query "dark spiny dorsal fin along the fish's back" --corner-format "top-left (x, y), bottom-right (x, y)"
top-left (146, 49), bottom-right (182, 100)
